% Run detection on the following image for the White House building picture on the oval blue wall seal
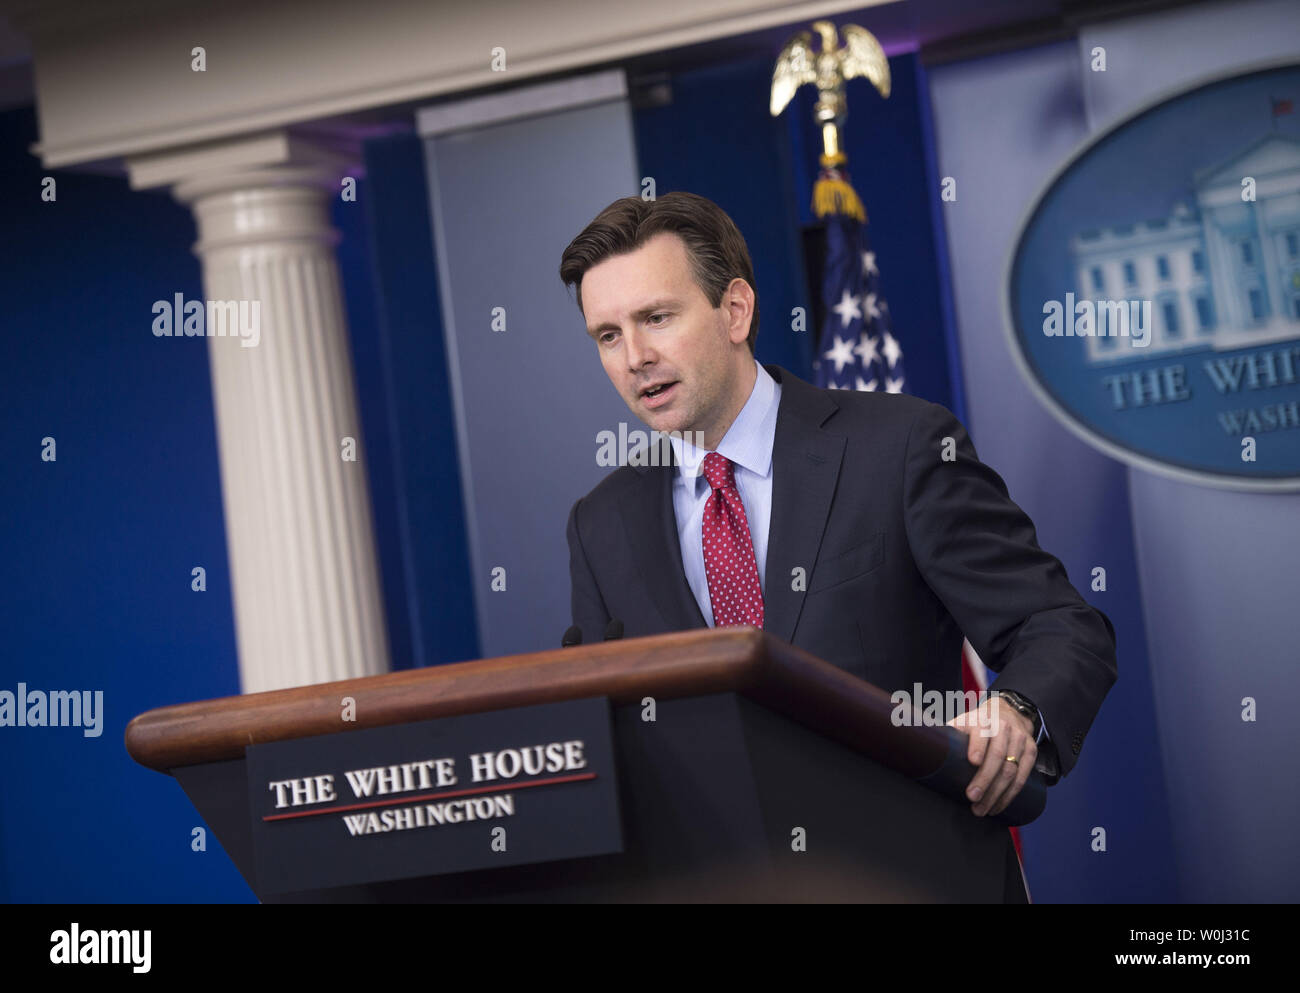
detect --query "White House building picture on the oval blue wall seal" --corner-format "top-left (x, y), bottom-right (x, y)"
top-left (1070, 133), bottom-right (1300, 363)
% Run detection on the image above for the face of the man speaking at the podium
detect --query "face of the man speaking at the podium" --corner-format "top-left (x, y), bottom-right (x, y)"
top-left (582, 231), bottom-right (754, 450)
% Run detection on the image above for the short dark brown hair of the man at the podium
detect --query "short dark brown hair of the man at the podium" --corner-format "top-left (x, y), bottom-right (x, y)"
top-left (560, 192), bottom-right (758, 354)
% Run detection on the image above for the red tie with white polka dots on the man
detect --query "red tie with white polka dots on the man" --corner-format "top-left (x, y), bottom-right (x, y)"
top-left (703, 452), bottom-right (763, 628)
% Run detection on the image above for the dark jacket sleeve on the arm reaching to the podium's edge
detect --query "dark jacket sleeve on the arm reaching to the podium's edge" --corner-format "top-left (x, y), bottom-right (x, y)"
top-left (902, 404), bottom-right (1117, 782)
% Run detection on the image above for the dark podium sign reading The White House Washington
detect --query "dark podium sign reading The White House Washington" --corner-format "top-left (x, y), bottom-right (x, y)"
top-left (246, 697), bottom-right (623, 893)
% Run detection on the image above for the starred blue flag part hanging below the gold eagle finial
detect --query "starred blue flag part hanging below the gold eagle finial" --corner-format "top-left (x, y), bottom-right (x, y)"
top-left (813, 178), bottom-right (905, 393)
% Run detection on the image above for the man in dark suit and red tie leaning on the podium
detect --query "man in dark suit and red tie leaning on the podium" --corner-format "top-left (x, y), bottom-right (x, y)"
top-left (560, 194), bottom-right (1117, 816)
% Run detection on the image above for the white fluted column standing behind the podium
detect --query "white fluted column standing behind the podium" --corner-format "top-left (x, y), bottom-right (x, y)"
top-left (174, 165), bottom-right (389, 693)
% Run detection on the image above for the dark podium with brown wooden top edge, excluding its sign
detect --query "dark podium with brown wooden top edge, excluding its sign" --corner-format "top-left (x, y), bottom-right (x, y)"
top-left (126, 628), bottom-right (1045, 902)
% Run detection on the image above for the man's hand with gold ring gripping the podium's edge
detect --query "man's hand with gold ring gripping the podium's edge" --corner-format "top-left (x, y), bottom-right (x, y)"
top-left (948, 697), bottom-right (1039, 818)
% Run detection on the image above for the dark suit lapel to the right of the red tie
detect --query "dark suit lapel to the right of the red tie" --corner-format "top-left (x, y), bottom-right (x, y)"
top-left (763, 365), bottom-right (845, 641)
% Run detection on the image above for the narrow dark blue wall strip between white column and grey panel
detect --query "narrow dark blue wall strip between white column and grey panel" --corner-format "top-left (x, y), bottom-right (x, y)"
top-left (353, 135), bottom-right (478, 668)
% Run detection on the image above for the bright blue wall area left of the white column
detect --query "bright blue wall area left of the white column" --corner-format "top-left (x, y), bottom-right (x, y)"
top-left (0, 109), bottom-right (252, 902)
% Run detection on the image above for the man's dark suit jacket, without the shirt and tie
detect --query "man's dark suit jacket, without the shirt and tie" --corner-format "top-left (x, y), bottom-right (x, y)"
top-left (568, 365), bottom-right (1117, 782)
